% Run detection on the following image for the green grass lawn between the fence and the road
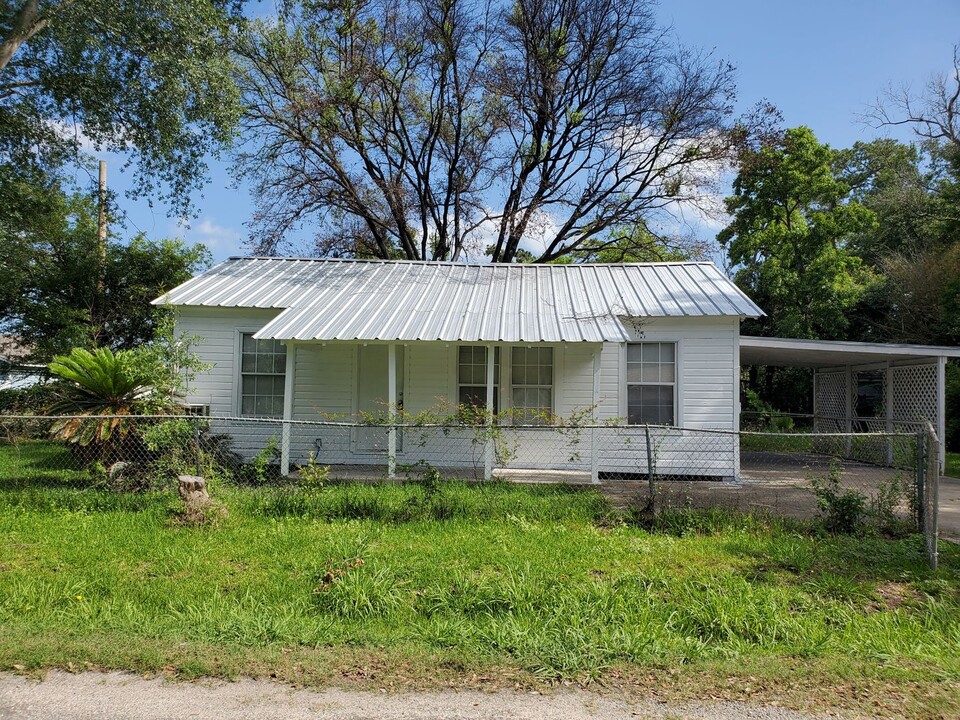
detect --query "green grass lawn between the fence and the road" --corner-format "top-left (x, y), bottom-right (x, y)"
top-left (0, 446), bottom-right (960, 718)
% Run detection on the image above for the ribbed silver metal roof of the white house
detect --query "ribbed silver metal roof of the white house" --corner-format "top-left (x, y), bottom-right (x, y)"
top-left (154, 257), bottom-right (763, 342)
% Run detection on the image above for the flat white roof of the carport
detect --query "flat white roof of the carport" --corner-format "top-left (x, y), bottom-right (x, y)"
top-left (740, 335), bottom-right (960, 367)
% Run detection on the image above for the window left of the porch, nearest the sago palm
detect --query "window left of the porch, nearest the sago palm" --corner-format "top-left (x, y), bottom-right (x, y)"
top-left (240, 333), bottom-right (287, 418)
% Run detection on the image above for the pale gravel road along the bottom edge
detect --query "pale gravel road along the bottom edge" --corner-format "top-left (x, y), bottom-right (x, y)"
top-left (0, 672), bottom-right (856, 720)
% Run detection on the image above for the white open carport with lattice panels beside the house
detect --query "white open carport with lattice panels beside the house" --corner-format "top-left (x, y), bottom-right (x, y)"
top-left (740, 336), bottom-right (960, 468)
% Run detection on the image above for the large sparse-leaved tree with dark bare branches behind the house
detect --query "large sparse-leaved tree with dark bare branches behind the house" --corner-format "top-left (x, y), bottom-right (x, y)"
top-left (239, 0), bottom-right (733, 262)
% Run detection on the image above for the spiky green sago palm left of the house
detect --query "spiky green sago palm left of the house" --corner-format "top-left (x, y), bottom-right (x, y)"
top-left (49, 348), bottom-right (157, 450)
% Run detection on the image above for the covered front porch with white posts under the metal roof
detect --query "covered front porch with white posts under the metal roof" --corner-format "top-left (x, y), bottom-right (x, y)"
top-left (279, 339), bottom-right (615, 481)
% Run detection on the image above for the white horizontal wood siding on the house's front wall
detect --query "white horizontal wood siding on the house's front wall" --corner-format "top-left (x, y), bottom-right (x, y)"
top-left (178, 308), bottom-right (739, 476)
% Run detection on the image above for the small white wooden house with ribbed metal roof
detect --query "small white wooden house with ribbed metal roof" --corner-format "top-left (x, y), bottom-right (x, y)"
top-left (155, 257), bottom-right (762, 478)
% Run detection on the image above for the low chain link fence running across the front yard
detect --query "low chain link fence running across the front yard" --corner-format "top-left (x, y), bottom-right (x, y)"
top-left (0, 415), bottom-right (939, 562)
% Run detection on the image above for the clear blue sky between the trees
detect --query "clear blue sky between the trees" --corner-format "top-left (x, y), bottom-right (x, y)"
top-left (77, 0), bottom-right (960, 260)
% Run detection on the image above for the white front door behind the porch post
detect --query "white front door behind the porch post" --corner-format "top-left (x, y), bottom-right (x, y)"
top-left (355, 345), bottom-right (404, 453)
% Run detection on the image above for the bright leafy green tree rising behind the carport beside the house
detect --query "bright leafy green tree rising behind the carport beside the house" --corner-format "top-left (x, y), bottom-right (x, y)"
top-left (717, 127), bottom-right (876, 339)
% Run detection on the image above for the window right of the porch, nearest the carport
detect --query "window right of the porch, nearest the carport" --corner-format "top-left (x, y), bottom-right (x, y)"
top-left (627, 343), bottom-right (677, 425)
